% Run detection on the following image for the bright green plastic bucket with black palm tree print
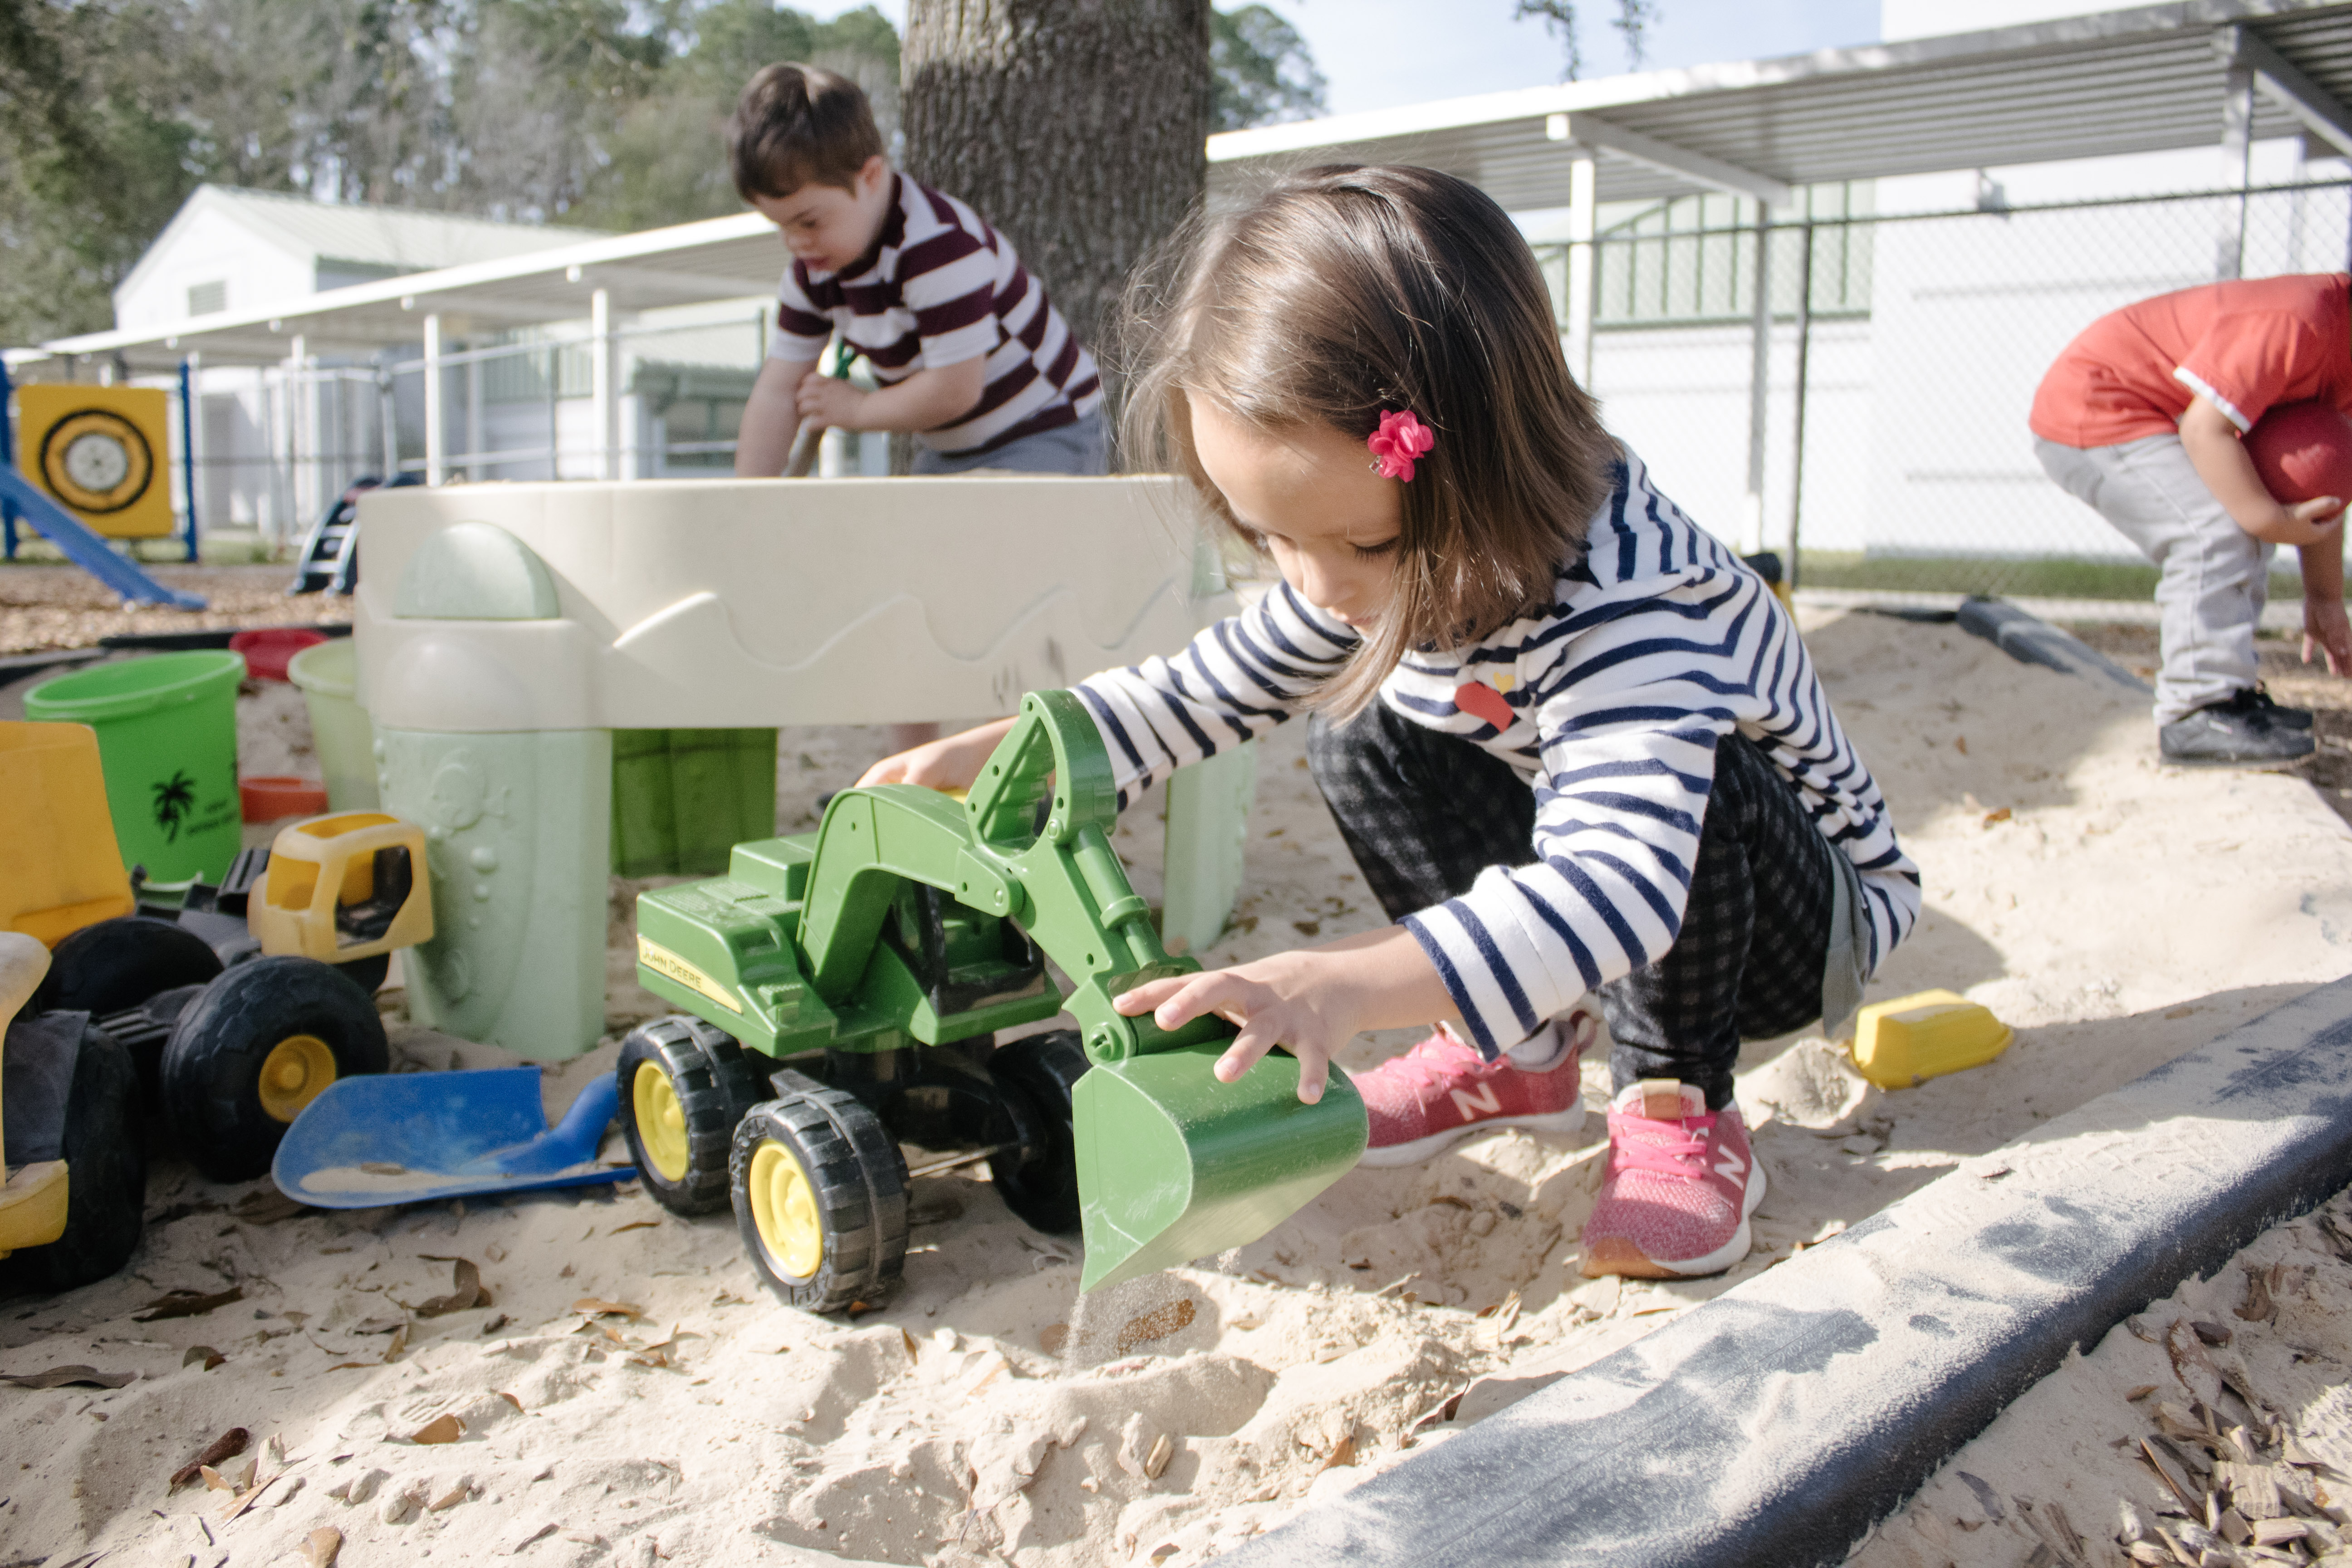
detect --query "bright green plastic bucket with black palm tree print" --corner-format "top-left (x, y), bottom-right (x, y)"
top-left (24, 651), bottom-right (245, 884)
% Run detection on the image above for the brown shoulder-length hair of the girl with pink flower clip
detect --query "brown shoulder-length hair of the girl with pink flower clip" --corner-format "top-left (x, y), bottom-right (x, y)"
top-left (1122, 165), bottom-right (1616, 717)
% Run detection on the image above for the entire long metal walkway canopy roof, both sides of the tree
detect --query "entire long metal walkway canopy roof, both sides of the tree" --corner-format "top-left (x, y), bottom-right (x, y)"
top-left (10, 0), bottom-right (2352, 367)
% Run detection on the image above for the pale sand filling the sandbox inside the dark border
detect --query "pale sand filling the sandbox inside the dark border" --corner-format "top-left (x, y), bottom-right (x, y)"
top-left (0, 613), bottom-right (2352, 1568)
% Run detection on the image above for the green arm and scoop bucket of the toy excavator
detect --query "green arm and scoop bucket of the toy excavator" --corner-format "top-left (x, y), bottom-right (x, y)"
top-left (800, 691), bottom-right (1367, 1291)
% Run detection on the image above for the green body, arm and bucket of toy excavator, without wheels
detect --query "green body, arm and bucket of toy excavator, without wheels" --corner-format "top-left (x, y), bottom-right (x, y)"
top-left (637, 691), bottom-right (1367, 1291)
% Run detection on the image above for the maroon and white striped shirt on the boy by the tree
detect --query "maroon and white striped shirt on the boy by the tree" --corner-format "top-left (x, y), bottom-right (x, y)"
top-left (767, 174), bottom-right (1103, 456)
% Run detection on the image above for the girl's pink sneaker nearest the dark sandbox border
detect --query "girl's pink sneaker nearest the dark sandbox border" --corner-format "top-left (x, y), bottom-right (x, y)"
top-left (1583, 1079), bottom-right (1764, 1279)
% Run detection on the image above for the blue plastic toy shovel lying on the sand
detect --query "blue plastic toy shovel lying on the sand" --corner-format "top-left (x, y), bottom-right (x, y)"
top-left (270, 1067), bottom-right (637, 1208)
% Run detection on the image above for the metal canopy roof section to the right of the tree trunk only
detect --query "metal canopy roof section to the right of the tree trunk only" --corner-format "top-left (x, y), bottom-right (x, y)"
top-left (1209, 0), bottom-right (2352, 211)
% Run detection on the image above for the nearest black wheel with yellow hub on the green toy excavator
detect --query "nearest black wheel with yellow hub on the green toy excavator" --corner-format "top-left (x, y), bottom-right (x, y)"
top-left (727, 1072), bottom-right (906, 1312)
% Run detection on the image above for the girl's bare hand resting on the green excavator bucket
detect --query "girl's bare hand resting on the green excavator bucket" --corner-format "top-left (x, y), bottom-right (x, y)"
top-left (1110, 926), bottom-right (1454, 1105)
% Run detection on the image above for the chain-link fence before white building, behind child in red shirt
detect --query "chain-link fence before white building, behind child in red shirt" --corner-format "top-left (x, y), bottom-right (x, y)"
top-left (1543, 181), bottom-right (2352, 597)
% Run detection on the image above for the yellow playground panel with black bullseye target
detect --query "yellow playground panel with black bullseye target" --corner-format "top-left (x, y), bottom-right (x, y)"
top-left (16, 383), bottom-right (172, 539)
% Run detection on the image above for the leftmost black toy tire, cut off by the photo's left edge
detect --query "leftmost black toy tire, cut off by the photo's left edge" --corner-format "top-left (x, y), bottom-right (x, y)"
top-left (0, 1025), bottom-right (146, 1295)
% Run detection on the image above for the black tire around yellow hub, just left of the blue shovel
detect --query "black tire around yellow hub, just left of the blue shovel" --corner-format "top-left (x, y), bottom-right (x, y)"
top-left (162, 957), bottom-right (393, 1182)
